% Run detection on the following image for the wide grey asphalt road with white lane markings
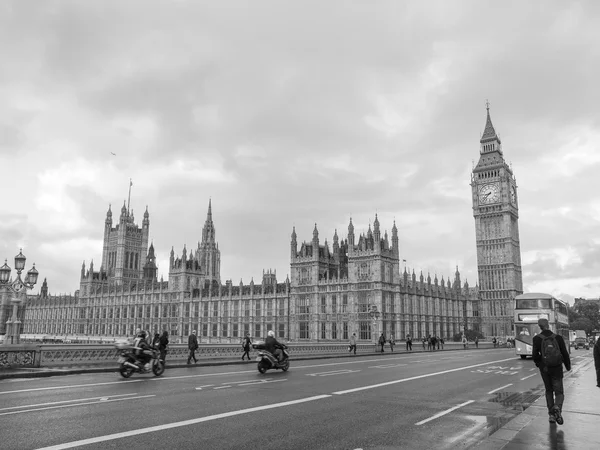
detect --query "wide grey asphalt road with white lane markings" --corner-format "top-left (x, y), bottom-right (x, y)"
top-left (0, 349), bottom-right (589, 450)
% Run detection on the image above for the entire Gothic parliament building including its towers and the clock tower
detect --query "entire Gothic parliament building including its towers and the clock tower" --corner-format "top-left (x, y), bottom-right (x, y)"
top-left (11, 106), bottom-right (523, 342)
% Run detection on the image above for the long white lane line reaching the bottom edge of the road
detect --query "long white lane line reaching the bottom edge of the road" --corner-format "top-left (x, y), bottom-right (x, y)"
top-left (38, 395), bottom-right (331, 450)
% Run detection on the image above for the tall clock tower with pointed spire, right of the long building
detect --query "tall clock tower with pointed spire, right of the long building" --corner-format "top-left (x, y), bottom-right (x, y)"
top-left (471, 103), bottom-right (523, 336)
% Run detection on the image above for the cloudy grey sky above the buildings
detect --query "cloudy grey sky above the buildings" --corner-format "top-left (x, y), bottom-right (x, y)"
top-left (0, 0), bottom-right (600, 301)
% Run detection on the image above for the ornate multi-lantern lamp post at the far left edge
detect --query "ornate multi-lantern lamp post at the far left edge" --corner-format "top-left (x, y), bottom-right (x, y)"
top-left (0, 249), bottom-right (39, 344)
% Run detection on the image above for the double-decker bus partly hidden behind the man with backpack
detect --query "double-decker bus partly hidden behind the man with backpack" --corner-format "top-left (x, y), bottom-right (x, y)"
top-left (514, 293), bottom-right (569, 359)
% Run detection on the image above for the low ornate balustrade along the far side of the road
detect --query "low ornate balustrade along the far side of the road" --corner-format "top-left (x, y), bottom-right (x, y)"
top-left (0, 341), bottom-right (492, 368)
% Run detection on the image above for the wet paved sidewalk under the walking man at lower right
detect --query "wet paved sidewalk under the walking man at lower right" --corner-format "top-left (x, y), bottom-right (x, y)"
top-left (473, 359), bottom-right (600, 450)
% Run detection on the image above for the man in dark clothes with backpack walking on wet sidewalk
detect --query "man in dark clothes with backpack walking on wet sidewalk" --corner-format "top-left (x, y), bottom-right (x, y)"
top-left (533, 319), bottom-right (571, 425)
